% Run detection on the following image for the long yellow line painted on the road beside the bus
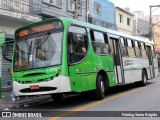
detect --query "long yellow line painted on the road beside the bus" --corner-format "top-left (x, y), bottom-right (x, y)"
top-left (50, 82), bottom-right (160, 120)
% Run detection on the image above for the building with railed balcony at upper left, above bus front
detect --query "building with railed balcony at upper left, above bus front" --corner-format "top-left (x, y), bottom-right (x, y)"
top-left (0, 0), bottom-right (41, 38)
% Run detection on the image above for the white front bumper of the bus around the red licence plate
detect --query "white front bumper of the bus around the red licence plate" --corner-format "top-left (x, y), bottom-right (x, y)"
top-left (13, 76), bottom-right (71, 96)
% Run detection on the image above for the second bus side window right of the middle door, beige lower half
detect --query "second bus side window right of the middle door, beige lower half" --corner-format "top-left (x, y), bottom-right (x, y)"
top-left (127, 39), bottom-right (136, 57)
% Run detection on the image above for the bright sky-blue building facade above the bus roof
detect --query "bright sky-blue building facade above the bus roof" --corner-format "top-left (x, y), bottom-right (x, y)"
top-left (88, 0), bottom-right (117, 30)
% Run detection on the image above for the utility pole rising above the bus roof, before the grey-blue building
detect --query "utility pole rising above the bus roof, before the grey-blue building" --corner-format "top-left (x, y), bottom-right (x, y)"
top-left (73, 0), bottom-right (81, 20)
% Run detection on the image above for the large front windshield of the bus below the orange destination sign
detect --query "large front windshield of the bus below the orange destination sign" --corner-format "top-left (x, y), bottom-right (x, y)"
top-left (14, 20), bottom-right (63, 71)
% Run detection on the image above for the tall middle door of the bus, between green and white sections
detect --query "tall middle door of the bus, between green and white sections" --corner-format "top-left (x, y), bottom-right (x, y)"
top-left (110, 38), bottom-right (124, 84)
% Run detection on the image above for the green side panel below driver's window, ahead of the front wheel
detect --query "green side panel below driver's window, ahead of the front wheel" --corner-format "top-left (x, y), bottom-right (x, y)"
top-left (69, 54), bottom-right (96, 92)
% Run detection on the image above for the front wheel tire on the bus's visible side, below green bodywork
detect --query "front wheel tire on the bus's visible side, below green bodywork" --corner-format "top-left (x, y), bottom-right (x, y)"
top-left (95, 75), bottom-right (105, 100)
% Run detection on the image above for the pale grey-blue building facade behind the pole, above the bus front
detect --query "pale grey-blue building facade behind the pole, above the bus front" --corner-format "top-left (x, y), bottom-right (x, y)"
top-left (30, 0), bottom-right (86, 21)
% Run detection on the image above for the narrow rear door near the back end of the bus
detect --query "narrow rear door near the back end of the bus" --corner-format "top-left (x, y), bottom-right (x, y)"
top-left (146, 45), bottom-right (155, 78)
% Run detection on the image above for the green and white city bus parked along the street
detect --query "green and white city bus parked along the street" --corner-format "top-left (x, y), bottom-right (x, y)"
top-left (5, 18), bottom-right (158, 101)
